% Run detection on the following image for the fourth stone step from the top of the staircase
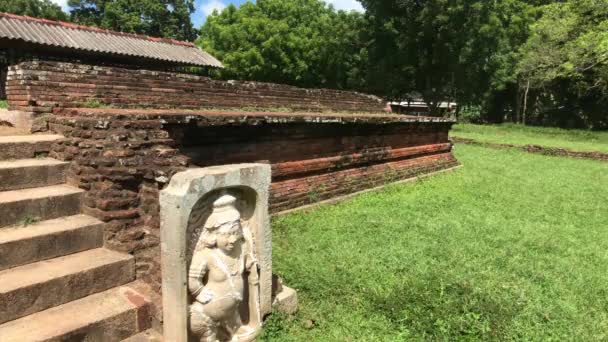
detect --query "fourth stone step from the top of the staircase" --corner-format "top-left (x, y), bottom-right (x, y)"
top-left (0, 215), bottom-right (103, 271)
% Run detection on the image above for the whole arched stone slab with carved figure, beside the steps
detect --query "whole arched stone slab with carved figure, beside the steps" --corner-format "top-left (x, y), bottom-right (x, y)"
top-left (160, 164), bottom-right (273, 342)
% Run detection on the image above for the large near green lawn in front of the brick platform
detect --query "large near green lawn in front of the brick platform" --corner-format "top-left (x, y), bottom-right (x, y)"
top-left (261, 145), bottom-right (608, 342)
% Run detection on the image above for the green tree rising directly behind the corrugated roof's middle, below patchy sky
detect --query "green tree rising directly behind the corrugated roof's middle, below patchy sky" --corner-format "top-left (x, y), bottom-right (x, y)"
top-left (68, 0), bottom-right (197, 41)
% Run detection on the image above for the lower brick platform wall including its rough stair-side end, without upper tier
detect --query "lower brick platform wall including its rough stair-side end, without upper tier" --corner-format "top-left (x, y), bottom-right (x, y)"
top-left (49, 109), bottom-right (458, 300)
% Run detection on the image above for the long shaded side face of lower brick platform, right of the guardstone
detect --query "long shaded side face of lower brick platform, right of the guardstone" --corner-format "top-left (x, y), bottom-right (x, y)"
top-left (167, 122), bottom-right (455, 212)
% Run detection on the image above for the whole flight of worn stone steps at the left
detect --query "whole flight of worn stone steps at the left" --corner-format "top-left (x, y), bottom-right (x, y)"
top-left (0, 135), bottom-right (151, 342)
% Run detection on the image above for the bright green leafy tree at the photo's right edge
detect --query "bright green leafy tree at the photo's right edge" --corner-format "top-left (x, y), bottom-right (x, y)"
top-left (517, 0), bottom-right (608, 128)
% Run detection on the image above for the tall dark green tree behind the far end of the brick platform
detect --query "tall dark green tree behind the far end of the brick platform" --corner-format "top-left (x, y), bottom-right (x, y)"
top-left (361, 0), bottom-right (549, 117)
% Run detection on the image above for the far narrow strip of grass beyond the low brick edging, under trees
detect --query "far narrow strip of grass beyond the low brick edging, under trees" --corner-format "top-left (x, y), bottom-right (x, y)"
top-left (451, 124), bottom-right (608, 152)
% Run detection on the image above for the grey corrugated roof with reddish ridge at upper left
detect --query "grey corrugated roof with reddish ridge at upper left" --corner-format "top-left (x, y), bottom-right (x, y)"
top-left (0, 13), bottom-right (223, 68)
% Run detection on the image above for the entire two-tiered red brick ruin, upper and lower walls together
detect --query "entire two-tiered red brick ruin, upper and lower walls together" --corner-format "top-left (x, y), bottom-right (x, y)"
top-left (2, 62), bottom-right (458, 324)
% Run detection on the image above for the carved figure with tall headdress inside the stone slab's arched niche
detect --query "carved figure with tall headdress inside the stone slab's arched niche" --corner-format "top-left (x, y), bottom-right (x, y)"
top-left (188, 193), bottom-right (261, 342)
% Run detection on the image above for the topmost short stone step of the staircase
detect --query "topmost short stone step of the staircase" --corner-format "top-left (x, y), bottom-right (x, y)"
top-left (0, 134), bottom-right (63, 160)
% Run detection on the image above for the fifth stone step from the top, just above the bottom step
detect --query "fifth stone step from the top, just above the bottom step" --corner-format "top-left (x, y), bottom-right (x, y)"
top-left (0, 248), bottom-right (135, 324)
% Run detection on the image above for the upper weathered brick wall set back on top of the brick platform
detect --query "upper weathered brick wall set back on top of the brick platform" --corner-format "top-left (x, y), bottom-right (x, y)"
top-left (7, 61), bottom-right (384, 113)
